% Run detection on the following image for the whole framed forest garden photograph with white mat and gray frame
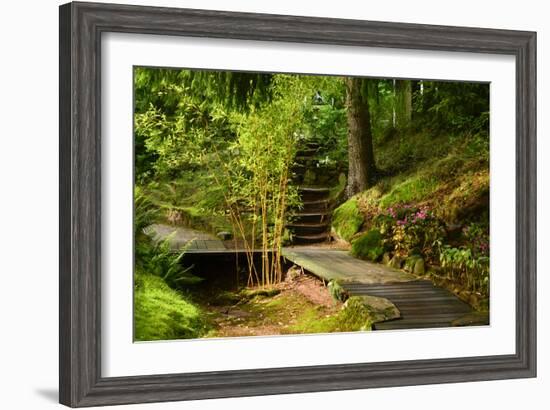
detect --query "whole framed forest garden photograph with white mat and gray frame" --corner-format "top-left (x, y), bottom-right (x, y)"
top-left (59, 2), bottom-right (536, 407)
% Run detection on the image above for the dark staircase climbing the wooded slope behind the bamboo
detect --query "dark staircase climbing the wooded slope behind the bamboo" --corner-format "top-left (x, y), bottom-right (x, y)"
top-left (287, 143), bottom-right (332, 245)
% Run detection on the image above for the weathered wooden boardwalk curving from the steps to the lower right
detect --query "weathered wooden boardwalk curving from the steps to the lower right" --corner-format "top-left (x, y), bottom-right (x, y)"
top-left (283, 247), bottom-right (488, 330)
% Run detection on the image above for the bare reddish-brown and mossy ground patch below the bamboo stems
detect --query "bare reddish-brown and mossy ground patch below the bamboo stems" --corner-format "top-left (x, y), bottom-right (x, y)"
top-left (192, 277), bottom-right (370, 337)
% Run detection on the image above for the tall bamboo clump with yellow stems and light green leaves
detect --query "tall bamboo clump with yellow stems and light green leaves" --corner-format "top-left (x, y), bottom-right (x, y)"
top-left (224, 75), bottom-right (313, 286)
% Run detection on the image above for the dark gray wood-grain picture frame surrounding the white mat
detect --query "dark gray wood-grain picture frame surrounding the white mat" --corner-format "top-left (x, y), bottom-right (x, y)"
top-left (59, 3), bottom-right (536, 407)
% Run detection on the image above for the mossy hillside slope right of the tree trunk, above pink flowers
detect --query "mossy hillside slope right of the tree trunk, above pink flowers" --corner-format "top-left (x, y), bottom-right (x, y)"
top-left (332, 133), bottom-right (489, 241)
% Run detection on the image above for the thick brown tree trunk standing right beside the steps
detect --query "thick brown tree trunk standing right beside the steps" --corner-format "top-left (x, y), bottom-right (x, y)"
top-left (346, 77), bottom-right (375, 197)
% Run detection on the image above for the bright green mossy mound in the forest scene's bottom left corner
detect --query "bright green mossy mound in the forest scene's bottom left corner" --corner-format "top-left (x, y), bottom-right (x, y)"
top-left (134, 274), bottom-right (207, 341)
